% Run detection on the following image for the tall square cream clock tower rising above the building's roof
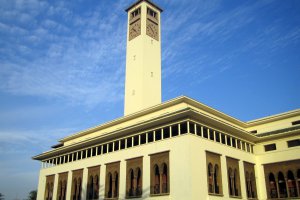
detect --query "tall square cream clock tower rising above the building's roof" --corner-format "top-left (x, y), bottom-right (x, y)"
top-left (124, 0), bottom-right (162, 115)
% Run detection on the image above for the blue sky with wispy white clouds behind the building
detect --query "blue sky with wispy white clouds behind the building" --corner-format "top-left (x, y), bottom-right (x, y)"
top-left (0, 0), bottom-right (300, 199)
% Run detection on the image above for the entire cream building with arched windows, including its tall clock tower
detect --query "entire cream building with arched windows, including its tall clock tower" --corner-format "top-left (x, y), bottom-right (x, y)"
top-left (33, 0), bottom-right (300, 200)
